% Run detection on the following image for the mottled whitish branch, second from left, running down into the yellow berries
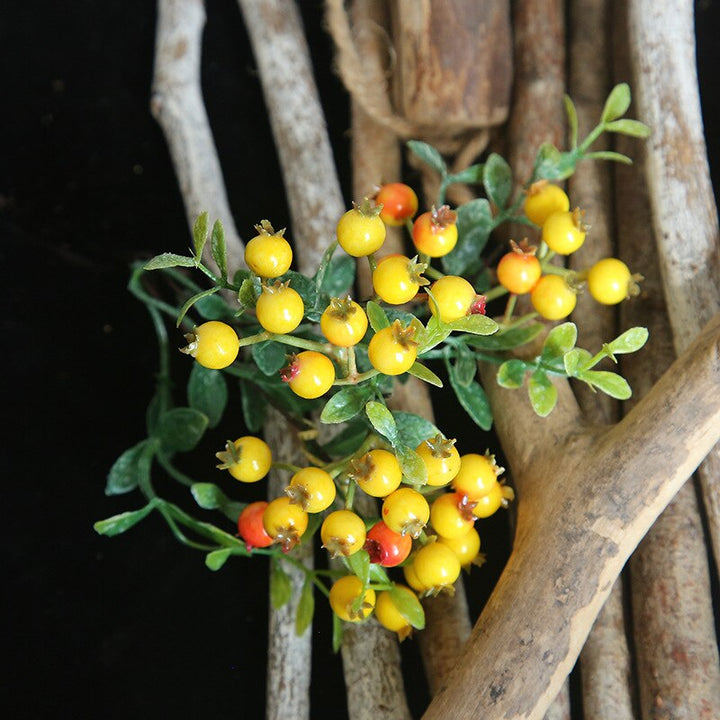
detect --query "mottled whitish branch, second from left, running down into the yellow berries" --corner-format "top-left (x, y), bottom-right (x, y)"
top-left (238, 0), bottom-right (344, 275)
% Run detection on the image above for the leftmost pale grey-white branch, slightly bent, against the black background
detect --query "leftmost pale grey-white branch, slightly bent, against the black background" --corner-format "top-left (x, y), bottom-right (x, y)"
top-left (150, 0), bottom-right (245, 271)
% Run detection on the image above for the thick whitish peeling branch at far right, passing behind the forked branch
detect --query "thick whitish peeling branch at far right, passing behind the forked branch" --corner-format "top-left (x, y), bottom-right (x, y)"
top-left (629, 0), bottom-right (720, 567)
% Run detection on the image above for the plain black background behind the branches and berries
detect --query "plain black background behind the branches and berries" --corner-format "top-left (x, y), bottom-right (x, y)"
top-left (0, 0), bottom-right (720, 719)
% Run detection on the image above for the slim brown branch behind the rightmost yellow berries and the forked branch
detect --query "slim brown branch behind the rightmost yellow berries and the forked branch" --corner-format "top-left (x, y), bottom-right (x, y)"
top-left (568, 0), bottom-right (638, 720)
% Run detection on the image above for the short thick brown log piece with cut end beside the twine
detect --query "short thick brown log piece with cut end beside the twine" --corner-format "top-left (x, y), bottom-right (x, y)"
top-left (392, 0), bottom-right (512, 131)
